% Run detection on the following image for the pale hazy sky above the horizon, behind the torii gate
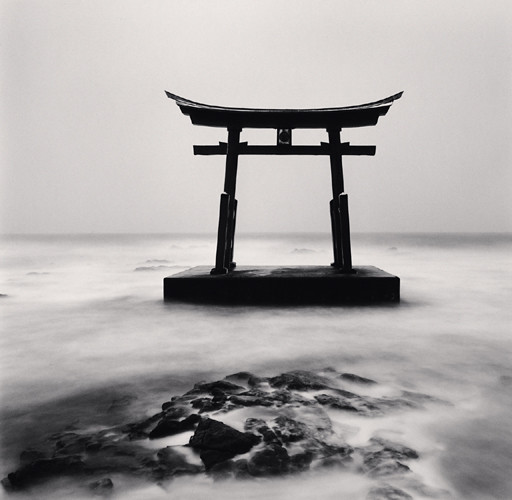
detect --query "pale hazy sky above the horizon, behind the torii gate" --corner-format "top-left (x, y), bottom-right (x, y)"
top-left (0, 0), bottom-right (512, 233)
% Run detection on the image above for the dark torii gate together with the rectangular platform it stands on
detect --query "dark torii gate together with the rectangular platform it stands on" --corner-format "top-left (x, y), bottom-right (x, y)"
top-left (164, 92), bottom-right (402, 304)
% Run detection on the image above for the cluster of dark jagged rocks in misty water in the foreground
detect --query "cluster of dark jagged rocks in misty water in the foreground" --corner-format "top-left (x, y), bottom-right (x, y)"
top-left (2, 369), bottom-right (444, 500)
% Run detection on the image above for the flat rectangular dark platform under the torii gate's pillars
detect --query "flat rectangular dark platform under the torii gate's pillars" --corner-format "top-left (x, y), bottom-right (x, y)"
top-left (164, 266), bottom-right (400, 305)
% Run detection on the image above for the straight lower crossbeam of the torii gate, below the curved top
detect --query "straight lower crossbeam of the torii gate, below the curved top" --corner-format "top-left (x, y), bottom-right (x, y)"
top-left (194, 142), bottom-right (376, 156)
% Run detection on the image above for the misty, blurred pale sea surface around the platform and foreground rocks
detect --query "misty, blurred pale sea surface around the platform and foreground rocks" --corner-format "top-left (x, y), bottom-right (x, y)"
top-left (0, 234), bottom-right (512, 500)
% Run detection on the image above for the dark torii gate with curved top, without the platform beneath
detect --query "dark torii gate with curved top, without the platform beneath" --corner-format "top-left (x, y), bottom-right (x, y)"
top-left (166, 92), bottom-right (403, 274)
